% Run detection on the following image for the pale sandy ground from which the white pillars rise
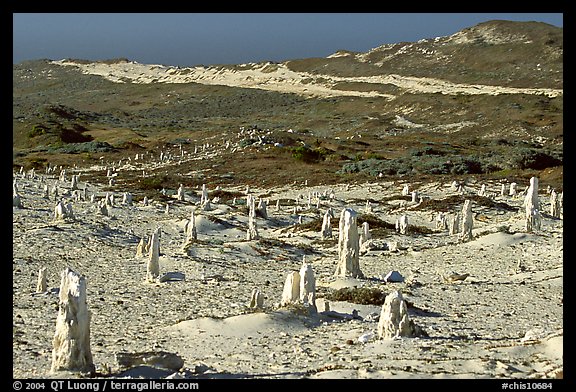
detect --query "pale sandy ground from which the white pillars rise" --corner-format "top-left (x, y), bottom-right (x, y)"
top-left (12, 155), bottom-right (563, 379)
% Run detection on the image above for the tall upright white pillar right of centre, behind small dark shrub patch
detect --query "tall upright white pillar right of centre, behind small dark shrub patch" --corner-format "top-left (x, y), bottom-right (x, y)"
top-left (335, 208), bottom-right (364, 278)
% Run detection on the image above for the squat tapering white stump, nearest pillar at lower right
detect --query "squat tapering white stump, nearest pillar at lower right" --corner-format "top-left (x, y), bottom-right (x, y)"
top-left (378, 291), bottom-right (413, 339)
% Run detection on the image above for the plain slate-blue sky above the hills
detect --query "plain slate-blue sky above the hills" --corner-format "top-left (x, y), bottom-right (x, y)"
top-left (12, 13), bottom-right (563, 66)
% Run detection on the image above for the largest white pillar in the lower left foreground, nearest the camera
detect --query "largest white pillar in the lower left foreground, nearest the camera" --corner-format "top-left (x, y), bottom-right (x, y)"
top-left (50, 268), bottom-right (95, 373)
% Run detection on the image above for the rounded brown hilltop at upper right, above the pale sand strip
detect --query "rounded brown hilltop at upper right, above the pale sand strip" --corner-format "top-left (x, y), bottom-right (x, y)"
top-left (288, 20), bottom-right (563, 89)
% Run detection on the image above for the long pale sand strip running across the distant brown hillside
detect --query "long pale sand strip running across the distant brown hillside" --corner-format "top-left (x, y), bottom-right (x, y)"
top-left (52, 60), bottom-right (563, 99)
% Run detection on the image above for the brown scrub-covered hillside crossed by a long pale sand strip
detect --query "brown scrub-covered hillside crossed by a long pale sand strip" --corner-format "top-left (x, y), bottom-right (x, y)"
top-left (13, 20), bottom-right (563, 190)
